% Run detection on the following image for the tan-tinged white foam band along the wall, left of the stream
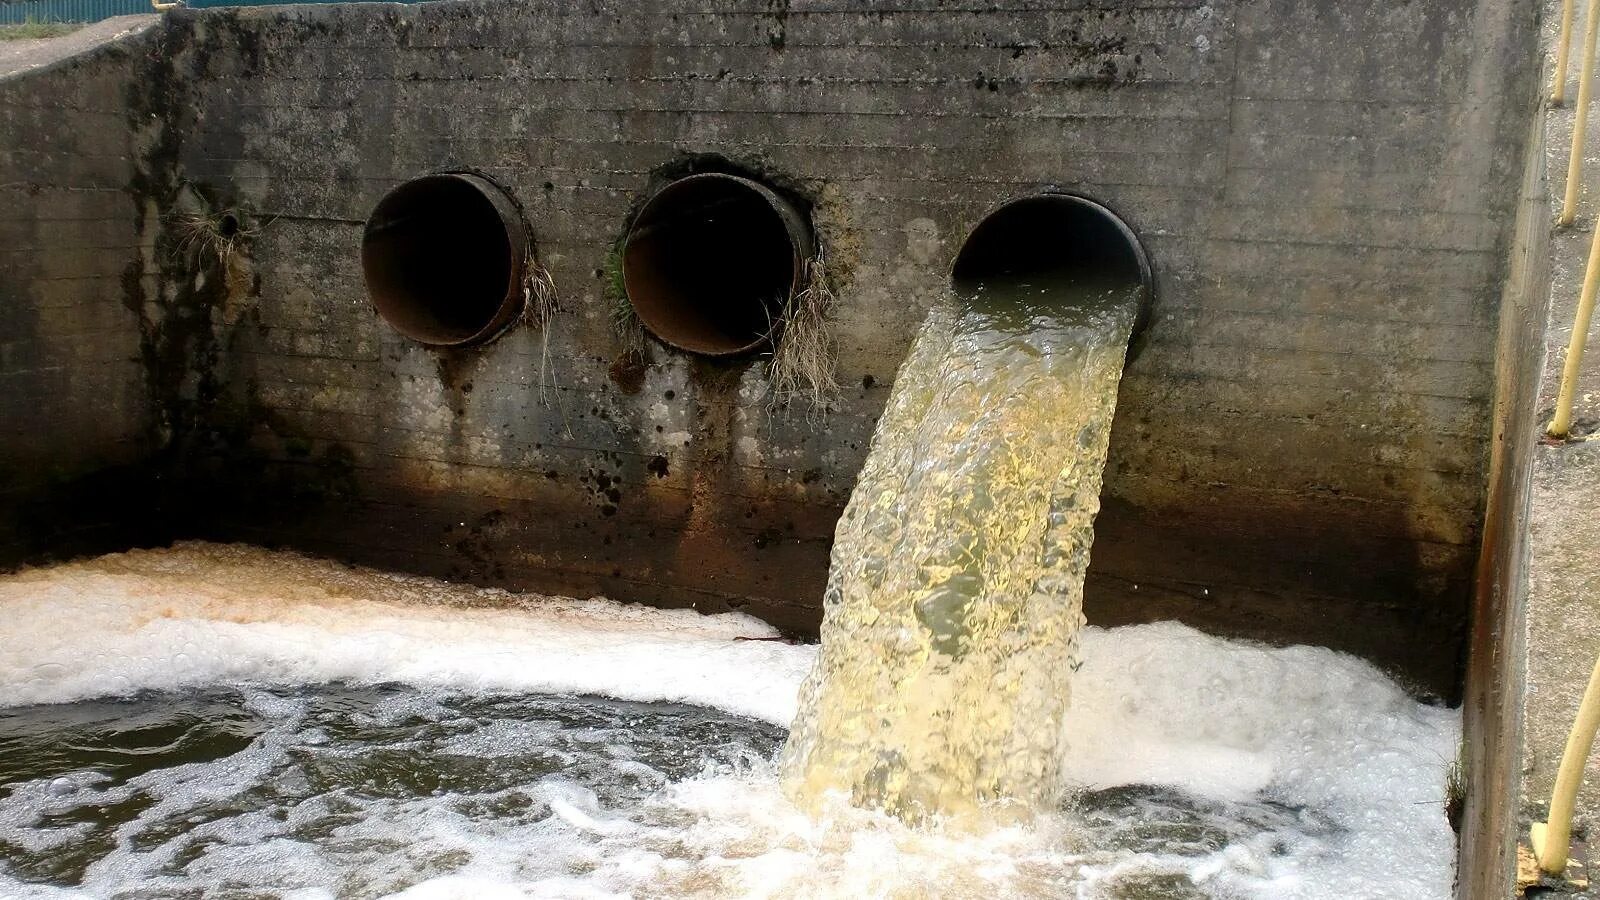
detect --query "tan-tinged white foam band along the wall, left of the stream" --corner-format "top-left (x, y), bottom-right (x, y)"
top-left (0, 543), bottom-right (811, 724)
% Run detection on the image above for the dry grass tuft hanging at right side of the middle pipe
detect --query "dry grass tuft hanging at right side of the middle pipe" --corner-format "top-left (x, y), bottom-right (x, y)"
top-left (766, 251), bottom-right (838, 412)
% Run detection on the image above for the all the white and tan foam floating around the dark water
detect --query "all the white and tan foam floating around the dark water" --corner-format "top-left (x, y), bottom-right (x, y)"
top-left (0, 544), bottom-right (1459, 900)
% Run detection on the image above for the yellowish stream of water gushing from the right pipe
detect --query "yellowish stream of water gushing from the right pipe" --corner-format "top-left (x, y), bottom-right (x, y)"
top-left (782, 273), bottom-right (1138, 820)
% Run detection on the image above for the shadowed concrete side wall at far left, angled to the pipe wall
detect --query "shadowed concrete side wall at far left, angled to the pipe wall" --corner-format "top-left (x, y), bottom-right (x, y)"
top-left (0, 18), bottom-right (160, 564)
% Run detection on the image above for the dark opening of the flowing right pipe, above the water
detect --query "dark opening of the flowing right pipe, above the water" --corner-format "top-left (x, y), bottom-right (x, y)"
top-left (950, 194), bottom-right (1154, 335)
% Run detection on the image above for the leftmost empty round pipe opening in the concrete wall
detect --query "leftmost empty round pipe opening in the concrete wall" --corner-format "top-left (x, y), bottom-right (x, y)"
top-left (362, 175), bottom-right (528, 346)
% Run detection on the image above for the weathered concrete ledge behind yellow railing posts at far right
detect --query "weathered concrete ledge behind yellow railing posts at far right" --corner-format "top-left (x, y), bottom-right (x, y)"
top-left (1518, 3), bottom-right (1600, 897)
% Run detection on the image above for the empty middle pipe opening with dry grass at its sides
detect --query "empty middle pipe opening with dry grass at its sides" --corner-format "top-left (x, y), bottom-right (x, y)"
top-left (622, 173), bottom-right (811, 356)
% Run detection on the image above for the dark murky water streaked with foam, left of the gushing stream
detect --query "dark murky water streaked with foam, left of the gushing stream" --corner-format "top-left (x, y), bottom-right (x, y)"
top-left (0, 685), bottom-right (782, 897)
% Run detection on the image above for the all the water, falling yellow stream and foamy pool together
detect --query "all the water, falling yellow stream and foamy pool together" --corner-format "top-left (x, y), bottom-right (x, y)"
top-left (0, 265), bottom-right (1461, 900)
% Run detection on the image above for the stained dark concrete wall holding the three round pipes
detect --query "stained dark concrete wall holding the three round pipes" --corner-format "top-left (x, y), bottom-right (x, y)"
top-left (0, 0), bottom-right (1536, 695)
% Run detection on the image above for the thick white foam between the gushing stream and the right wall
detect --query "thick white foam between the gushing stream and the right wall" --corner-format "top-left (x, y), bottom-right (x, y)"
top-left (1062, 623), bottom-right (1461, 900)
